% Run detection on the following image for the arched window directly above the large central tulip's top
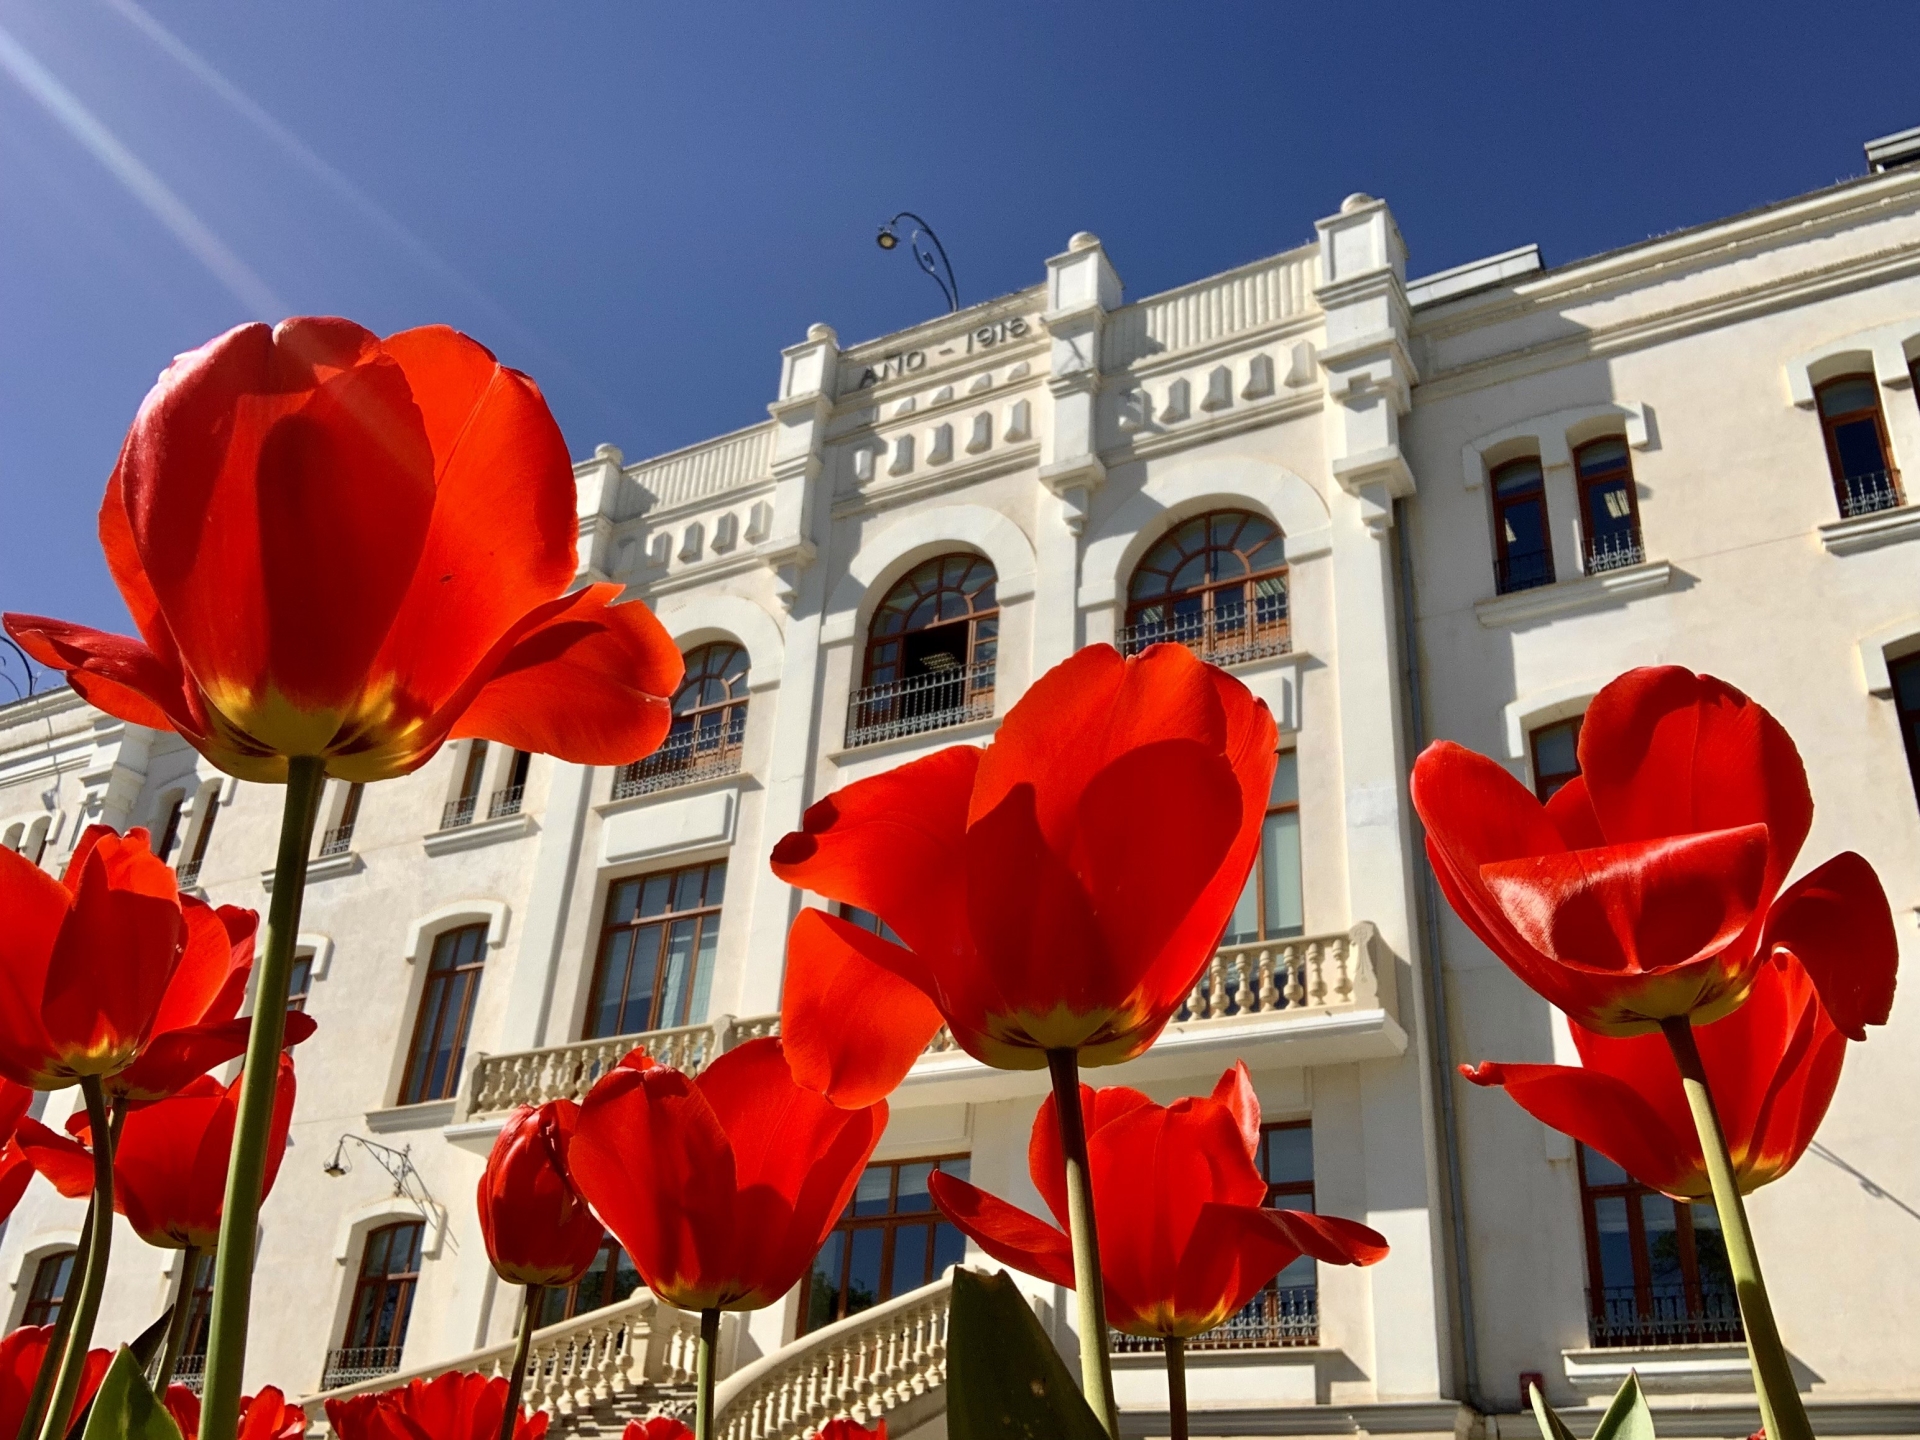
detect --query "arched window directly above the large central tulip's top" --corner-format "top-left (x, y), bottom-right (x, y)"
top-left (1121, 511), bottom-right (1292, 664)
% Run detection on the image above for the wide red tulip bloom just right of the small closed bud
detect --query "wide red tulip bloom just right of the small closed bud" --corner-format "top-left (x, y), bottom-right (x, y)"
top-left (566, 1039), bottom-right (887, 1309)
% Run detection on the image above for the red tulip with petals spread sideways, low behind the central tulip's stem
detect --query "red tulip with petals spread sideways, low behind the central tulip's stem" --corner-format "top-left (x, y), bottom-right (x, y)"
top-left (931, 1064), bottom-right (1386, 1338)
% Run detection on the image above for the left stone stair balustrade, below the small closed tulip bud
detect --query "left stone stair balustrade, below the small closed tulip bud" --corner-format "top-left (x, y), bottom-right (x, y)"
top-left (300, 1290), bottom-right (701, 1421)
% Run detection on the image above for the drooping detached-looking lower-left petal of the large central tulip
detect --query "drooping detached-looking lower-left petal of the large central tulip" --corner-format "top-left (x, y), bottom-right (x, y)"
top-left (780, 908), bottom-right (941, 1108)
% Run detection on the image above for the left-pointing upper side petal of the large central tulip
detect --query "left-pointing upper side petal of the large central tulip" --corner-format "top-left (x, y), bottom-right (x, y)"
top-left (772, 745), bottom-right (981, 973)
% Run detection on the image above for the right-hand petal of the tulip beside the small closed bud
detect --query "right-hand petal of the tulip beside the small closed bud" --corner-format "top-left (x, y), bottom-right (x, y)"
top-left (695, 1037), bottom-right (887, 1308)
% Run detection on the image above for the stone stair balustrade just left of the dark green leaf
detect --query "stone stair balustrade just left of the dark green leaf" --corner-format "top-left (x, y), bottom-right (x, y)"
top-left (714, 1273), bottom-right (952, 1440)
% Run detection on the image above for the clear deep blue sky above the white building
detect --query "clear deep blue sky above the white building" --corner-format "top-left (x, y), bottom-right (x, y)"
top-left (0, 0), bottom-right (1920, 660)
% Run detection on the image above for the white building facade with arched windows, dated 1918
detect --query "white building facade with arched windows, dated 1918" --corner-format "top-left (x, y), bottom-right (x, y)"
top-left (0, 123), bottom-right (1920, 1436)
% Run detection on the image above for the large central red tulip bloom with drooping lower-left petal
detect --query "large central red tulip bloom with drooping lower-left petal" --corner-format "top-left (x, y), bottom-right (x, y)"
top-left (774, 645), bottom-right (1277, 1104)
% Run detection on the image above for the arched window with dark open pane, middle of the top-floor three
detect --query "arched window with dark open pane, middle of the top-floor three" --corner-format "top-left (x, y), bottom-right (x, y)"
top-left (847, 555), bottom-right (1000, 745)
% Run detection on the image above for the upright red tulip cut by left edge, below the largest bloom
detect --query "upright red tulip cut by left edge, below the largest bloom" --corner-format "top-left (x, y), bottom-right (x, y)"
top-left (0, 826), bottom-right (186, 1091)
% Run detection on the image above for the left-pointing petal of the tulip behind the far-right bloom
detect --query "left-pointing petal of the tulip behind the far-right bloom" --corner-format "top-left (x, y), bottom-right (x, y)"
top-left (1459, 1060), bottom-right (1707, 1198)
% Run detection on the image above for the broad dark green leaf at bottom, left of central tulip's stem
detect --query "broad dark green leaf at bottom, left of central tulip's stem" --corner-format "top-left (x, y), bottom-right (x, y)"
top-left (948, 1265), bottom-right (1106, 1440)
